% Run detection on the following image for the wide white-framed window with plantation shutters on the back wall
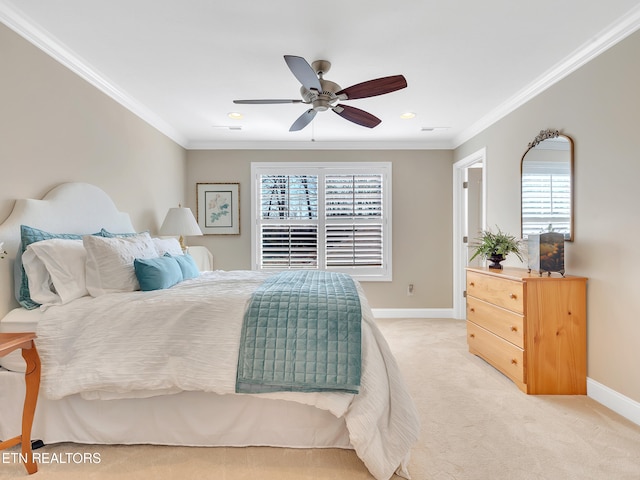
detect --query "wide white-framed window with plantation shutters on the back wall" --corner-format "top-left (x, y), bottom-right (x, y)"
top-left (251, 163), bottom-right (391, 280)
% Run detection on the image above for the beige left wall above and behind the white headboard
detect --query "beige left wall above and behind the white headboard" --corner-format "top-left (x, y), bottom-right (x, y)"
top-left (0, 24), bottom-right (186, 312)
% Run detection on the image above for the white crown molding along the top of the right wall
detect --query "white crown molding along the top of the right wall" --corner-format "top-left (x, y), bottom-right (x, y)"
top-left (453, 5), bottom-right (640, 148)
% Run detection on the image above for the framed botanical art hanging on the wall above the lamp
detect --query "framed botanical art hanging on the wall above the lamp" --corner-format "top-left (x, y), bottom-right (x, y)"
top-left (196, 183), bottom-right (240, 235)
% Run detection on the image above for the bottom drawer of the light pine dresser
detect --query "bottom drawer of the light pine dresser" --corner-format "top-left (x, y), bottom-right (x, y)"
top-left (467, 321), bottom-right (526, 384)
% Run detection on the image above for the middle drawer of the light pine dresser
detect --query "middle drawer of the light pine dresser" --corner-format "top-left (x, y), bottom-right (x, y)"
top-left (467, 297), bottom-right (524, 348)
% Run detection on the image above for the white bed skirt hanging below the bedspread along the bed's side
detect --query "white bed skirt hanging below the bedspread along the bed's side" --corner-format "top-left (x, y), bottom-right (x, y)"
top-left (0, 370), bottom-right (353, 449)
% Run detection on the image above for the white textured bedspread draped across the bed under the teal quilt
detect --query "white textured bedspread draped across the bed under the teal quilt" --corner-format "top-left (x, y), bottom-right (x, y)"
top-left (37, 271), bottom-right (419, 480)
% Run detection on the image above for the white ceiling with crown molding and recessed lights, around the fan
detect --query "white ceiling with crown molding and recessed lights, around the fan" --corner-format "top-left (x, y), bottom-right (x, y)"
top-left (0, 0), bottom-right (640, 148)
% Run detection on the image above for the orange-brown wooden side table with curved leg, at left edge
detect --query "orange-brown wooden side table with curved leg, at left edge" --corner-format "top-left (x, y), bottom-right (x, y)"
top-left (0, 332), bottom-right (40, 474)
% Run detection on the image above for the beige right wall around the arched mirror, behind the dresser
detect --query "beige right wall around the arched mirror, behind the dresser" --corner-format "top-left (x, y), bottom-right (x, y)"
top-left (455, 27), bottom-right (640, 401)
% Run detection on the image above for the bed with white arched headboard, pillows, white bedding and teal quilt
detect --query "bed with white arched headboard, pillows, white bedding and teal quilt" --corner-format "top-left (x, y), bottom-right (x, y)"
top-left (0, 183), bottom-right (420, 480)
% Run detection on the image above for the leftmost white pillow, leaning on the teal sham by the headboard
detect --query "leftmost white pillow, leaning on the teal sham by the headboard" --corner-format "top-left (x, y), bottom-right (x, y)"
top-left (24, 238), bottom-right (89, 305)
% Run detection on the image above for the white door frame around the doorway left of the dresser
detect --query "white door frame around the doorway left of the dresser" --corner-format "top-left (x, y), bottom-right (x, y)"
top-left (453, 148), bottom-right (487, 319)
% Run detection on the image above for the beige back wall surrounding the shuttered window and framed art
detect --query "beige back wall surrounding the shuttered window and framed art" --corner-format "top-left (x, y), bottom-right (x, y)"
top-left (187, 150), bottom-right (453, 308)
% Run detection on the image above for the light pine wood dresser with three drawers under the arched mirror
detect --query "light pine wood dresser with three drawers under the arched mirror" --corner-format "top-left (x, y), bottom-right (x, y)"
top-left (467, 267), bottom-right (587, 395)
